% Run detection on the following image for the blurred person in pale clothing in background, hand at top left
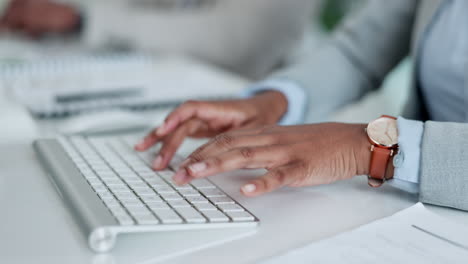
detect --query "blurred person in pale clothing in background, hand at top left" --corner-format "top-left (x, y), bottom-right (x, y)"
top-left (0, 0), bottom-right (322, 79)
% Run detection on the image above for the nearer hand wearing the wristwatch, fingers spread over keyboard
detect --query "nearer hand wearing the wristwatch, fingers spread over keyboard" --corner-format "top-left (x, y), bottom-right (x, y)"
top-left (174, 123), bottom-right (371, 196)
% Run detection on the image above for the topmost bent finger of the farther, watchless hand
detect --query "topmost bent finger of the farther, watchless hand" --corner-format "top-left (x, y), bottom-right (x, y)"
top-left (156, 101), bottom-right (219, 136)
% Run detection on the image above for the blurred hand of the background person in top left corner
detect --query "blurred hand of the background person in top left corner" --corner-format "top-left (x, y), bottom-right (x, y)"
top-left (0, 0), bottom-right (80, 37)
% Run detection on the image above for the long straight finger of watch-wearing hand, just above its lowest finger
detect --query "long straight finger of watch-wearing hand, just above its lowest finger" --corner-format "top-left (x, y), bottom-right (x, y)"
top-left (186, 145), bottom-right (291, 178)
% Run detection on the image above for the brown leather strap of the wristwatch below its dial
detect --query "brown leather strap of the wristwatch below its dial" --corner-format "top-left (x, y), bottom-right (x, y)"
top-left (368, 146), bottom-right (393, 187)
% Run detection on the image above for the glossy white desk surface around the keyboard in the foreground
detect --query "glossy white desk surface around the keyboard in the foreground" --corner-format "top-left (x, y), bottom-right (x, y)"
top-left (0, 58), bottom-right (468, 264)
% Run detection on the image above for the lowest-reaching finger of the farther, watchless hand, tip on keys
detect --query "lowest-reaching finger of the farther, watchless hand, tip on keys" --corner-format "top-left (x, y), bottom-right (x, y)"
top-left (153, 119), bottom-right (204, 170)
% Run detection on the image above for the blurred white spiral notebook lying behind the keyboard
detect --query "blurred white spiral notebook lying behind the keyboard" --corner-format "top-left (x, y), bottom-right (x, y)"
top-left (0, 54), bottom-right (246, 118)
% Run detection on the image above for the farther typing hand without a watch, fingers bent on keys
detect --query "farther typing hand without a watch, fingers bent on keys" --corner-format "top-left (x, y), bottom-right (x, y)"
top-left (135, 91), bottom-right (287, 170)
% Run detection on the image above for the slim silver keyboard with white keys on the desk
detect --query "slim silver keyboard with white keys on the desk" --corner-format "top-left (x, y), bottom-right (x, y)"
top-left (34, 137), bottom-right (259, 252)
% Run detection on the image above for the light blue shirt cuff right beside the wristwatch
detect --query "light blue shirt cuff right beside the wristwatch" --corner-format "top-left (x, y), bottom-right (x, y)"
top-left (388, 117), bottom-right (424, 193)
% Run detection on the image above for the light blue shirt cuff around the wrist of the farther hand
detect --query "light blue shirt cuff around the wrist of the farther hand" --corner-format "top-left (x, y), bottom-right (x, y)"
top-left (242, 79), bottom-right (307, 125)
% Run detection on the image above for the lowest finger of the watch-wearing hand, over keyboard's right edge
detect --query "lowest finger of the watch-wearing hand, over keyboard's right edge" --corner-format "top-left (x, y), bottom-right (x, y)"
top-left (241, 164), bottom-right (307, 197)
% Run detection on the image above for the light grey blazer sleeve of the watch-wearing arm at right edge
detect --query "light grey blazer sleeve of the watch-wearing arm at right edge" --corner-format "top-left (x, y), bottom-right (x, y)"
top-left (420, 121), bottom-right (468, 211)
